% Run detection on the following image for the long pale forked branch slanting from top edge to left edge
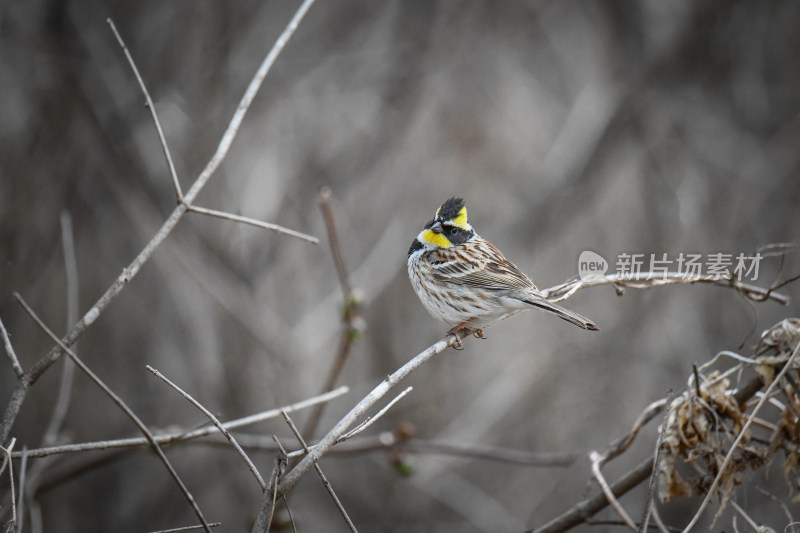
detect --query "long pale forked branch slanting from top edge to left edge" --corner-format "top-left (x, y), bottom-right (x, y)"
top-left (0, 0), bottom-right (314, 442)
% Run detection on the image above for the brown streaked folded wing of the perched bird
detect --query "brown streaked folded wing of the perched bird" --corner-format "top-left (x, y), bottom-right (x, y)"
top-left (432, 236), bottom-right (535, 290)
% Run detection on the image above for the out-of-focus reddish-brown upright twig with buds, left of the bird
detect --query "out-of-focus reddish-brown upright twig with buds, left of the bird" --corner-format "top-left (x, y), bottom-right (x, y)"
top-left (303, 187), bottom-right (363, 439)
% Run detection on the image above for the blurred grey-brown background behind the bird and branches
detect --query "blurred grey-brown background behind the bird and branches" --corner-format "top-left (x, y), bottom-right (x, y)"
top-left (0, 0), bottom-right (800, 532)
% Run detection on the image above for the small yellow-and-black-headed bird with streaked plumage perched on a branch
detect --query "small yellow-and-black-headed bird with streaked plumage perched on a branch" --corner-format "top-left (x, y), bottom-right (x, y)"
top-left (408, 198), bottom-right (599, 343)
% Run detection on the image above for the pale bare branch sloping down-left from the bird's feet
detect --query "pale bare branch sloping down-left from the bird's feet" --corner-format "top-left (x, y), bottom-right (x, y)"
top-left (278, 330), bottom-right (467, 494)
